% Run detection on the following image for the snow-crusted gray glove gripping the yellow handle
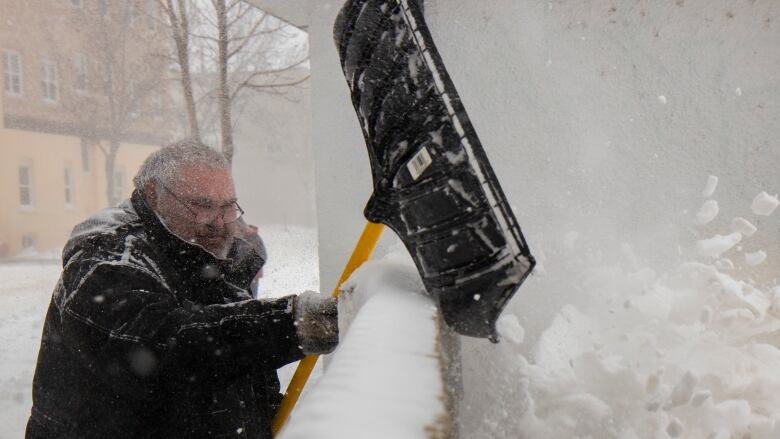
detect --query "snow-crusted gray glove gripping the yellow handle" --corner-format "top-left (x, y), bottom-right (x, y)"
top-left (295, 291), bottom-right (339, 354)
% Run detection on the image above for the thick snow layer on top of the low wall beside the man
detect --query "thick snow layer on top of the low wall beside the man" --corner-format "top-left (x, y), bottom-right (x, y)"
top-left (280, 261), bottom-right (450, 439)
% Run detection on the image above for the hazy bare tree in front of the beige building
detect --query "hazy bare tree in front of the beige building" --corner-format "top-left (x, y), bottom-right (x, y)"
top-left (70, 0), bottom-right (174, 206)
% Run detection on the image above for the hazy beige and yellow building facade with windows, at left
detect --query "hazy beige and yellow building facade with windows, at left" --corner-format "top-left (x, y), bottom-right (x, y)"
top-left (0, 0), bottom-right (171, 258)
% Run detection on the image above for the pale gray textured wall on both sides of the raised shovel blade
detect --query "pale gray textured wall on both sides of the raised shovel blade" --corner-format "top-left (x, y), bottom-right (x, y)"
top-left (310, 0), bottom-right (780, 302)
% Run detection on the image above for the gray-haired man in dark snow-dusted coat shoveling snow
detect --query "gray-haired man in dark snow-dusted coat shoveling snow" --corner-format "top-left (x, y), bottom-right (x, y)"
top-left (27, 142), bottom-right (338, 439)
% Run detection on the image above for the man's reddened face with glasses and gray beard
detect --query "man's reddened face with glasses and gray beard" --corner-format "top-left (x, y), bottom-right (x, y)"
top-left (147, 166), bottom-right (236, 258)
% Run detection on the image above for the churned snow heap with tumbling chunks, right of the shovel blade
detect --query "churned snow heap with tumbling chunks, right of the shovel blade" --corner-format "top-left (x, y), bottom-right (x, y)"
top-left (461, 180), bottom-right (780, 439)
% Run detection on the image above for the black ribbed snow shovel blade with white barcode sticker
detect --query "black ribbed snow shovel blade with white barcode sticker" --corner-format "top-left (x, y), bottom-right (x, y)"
top-left (334, 0), bottom-right (534, 341)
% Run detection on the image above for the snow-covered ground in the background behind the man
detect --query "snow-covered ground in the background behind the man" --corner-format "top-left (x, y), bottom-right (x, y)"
top-left (0, 226), bottom-right (319, 439)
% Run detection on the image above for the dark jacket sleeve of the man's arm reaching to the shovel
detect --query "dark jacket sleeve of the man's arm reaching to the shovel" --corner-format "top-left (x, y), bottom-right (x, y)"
top-left (59, 261), bottom-right (303, 395)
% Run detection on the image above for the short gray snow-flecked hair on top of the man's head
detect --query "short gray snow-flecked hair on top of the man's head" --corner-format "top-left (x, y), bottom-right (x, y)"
top-left (133, 140), bottom-right (230, 191)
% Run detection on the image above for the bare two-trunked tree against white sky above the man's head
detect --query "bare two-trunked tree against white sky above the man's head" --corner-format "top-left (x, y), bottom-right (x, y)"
top-left (157, 0), bottom-right (309, 162)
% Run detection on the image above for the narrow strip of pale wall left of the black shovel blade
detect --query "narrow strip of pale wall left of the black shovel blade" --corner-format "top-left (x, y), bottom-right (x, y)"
top-left (309, 1), bottom-right (378, 291)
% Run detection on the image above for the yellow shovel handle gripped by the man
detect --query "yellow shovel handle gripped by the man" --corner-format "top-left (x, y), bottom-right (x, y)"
top-left (271, 222), bottom-right (384, 436)
